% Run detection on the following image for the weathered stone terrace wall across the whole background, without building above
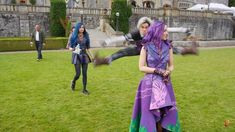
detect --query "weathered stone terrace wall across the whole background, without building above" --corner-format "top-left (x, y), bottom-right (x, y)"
top-left (0, 3), bottom-right (234, 40)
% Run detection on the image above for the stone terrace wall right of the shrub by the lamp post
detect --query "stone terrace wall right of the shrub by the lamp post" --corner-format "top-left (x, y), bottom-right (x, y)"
top-left (129, 9), bottom-right (234, 40)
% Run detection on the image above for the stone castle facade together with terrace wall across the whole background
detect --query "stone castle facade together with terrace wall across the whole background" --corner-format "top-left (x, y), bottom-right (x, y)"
top-left (0, 0), bottom-right (234, 40)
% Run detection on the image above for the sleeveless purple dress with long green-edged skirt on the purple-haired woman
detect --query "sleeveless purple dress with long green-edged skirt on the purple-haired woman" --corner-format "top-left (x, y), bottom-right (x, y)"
top-left (129, 42), bottom-right (180, 132)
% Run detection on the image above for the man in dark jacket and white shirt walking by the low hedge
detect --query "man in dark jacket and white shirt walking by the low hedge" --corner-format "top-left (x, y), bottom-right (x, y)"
top-left (30, 24), bottom-right (45, 61)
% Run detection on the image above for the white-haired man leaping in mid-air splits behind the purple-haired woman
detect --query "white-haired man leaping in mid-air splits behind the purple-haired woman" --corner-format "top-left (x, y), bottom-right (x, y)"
top-left (94, 17), bottom-right (198, 66)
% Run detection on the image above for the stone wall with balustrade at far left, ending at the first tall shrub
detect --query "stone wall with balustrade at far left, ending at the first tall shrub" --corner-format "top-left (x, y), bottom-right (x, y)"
top-left (0, 0), bottom-right (50, 37)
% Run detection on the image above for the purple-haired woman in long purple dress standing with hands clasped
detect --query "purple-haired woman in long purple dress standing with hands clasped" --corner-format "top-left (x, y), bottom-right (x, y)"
top-left (129, 21), bottom-right (180, 132)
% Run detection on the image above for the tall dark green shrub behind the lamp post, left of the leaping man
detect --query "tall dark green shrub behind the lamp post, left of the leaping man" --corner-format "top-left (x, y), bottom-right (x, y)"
top-left (111, 0), bottom-right (132, 33)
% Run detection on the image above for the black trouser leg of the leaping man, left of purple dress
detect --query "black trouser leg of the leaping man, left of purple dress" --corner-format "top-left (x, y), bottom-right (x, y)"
top-left (110, 47), bottom-right (140, 61)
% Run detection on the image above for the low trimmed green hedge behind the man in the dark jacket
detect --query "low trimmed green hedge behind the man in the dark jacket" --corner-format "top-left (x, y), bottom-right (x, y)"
top-left (0, 37), bottom-right (68, 52)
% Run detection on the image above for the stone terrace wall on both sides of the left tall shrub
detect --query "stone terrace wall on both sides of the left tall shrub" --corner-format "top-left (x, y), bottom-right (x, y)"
top-left (0, 4), bottom-right (111, 37)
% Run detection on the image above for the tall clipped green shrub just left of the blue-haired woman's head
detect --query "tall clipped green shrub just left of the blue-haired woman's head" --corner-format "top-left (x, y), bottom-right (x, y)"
top-left (50, 0), bottom-right (66, 37)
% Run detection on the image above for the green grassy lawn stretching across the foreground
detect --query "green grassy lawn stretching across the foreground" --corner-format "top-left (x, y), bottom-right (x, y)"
top-left (0, 48), bottom-right (235, 132)
